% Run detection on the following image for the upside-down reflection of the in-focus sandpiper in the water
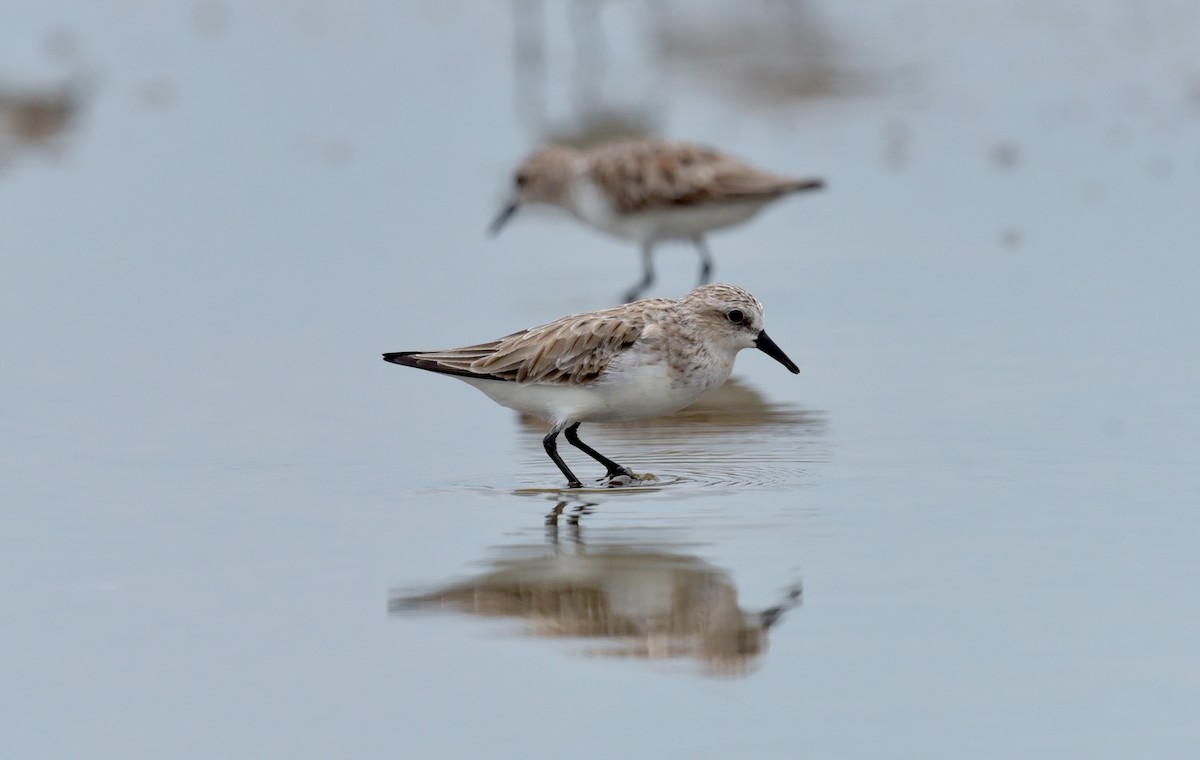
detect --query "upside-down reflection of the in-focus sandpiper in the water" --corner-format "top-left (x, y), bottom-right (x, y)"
top-left (389, 504), bottom-right (800, 675)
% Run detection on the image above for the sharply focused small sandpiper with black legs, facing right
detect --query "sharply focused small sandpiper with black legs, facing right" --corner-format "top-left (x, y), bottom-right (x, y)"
top-left (383, 285), bottom-right (800, 489)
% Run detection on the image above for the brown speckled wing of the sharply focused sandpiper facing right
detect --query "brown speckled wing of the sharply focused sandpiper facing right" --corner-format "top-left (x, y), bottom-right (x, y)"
top-left (384, 301), bottom-right (653, 385)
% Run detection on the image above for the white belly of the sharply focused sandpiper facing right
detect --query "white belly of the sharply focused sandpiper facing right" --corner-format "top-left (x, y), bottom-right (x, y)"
top-left (461, 364), bottom-right (728, 423)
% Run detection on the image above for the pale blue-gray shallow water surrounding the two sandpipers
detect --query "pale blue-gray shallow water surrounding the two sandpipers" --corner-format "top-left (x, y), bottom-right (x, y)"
top-left (0, 0), bottom-right (1200, 758)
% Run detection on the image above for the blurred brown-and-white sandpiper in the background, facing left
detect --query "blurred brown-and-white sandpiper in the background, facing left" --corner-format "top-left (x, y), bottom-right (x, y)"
top-left (490, 139), bottom-right (824, 301)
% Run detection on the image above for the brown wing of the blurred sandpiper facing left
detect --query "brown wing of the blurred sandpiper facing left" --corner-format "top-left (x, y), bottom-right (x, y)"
top-left (588, 140), bottom-right (822, 214)
